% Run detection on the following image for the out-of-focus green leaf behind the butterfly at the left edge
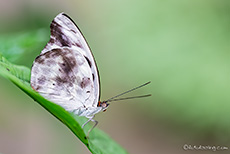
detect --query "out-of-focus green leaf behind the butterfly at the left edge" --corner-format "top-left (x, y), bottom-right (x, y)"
top-left (0, 29), bottom-right (49, 66)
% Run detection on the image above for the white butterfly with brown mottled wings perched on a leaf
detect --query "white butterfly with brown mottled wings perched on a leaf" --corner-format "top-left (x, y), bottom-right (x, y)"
top-left (30, 13), bottom-right (150, 137)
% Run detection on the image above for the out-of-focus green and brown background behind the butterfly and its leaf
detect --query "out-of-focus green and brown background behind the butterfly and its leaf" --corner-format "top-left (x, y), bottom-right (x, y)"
top-left (0, 0), bottom-right (230, 154)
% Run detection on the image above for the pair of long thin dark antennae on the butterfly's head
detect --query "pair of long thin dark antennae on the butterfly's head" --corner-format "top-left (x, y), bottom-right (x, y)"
top-left (105, 81), bottom-right (151, 102)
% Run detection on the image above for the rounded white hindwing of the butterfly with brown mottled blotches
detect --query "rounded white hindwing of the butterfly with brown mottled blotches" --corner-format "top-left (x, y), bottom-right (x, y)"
top-left (31, 48), bottom-right (94, 111)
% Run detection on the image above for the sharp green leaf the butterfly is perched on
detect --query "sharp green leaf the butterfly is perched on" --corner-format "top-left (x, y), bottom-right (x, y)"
top-left (0, 54), bottom-right (127, 154)
